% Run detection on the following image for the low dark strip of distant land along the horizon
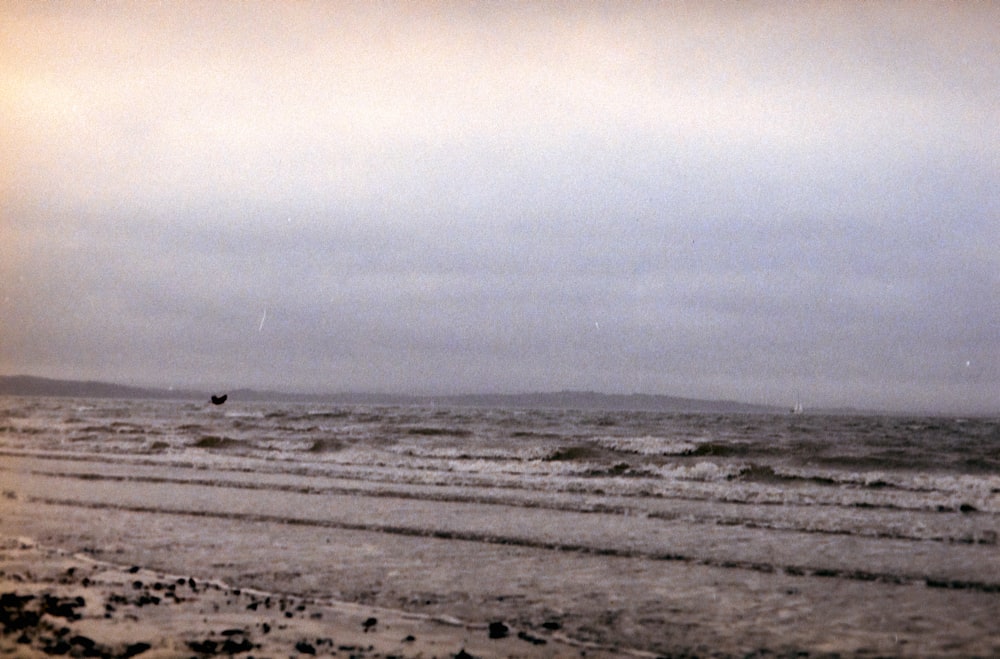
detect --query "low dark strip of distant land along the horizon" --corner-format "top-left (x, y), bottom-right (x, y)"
top-left (0, 375), bottom-right (788, 414)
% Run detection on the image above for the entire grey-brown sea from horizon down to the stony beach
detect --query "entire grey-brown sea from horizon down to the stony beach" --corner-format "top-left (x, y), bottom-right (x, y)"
top-left (0, 397), bottom-right (1000, 656)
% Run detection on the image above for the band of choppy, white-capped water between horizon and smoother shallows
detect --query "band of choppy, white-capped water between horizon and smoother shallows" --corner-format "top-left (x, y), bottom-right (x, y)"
top-left (0, 397), bottom-right (1000, 514)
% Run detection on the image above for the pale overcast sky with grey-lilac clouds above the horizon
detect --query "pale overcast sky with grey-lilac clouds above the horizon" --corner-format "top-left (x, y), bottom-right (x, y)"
top-left (0, 1), bottom-right (1000, 412)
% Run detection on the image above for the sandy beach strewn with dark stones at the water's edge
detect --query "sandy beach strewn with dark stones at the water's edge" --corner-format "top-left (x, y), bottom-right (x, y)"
top-left (0, 537), bottom-right (610, 657)
